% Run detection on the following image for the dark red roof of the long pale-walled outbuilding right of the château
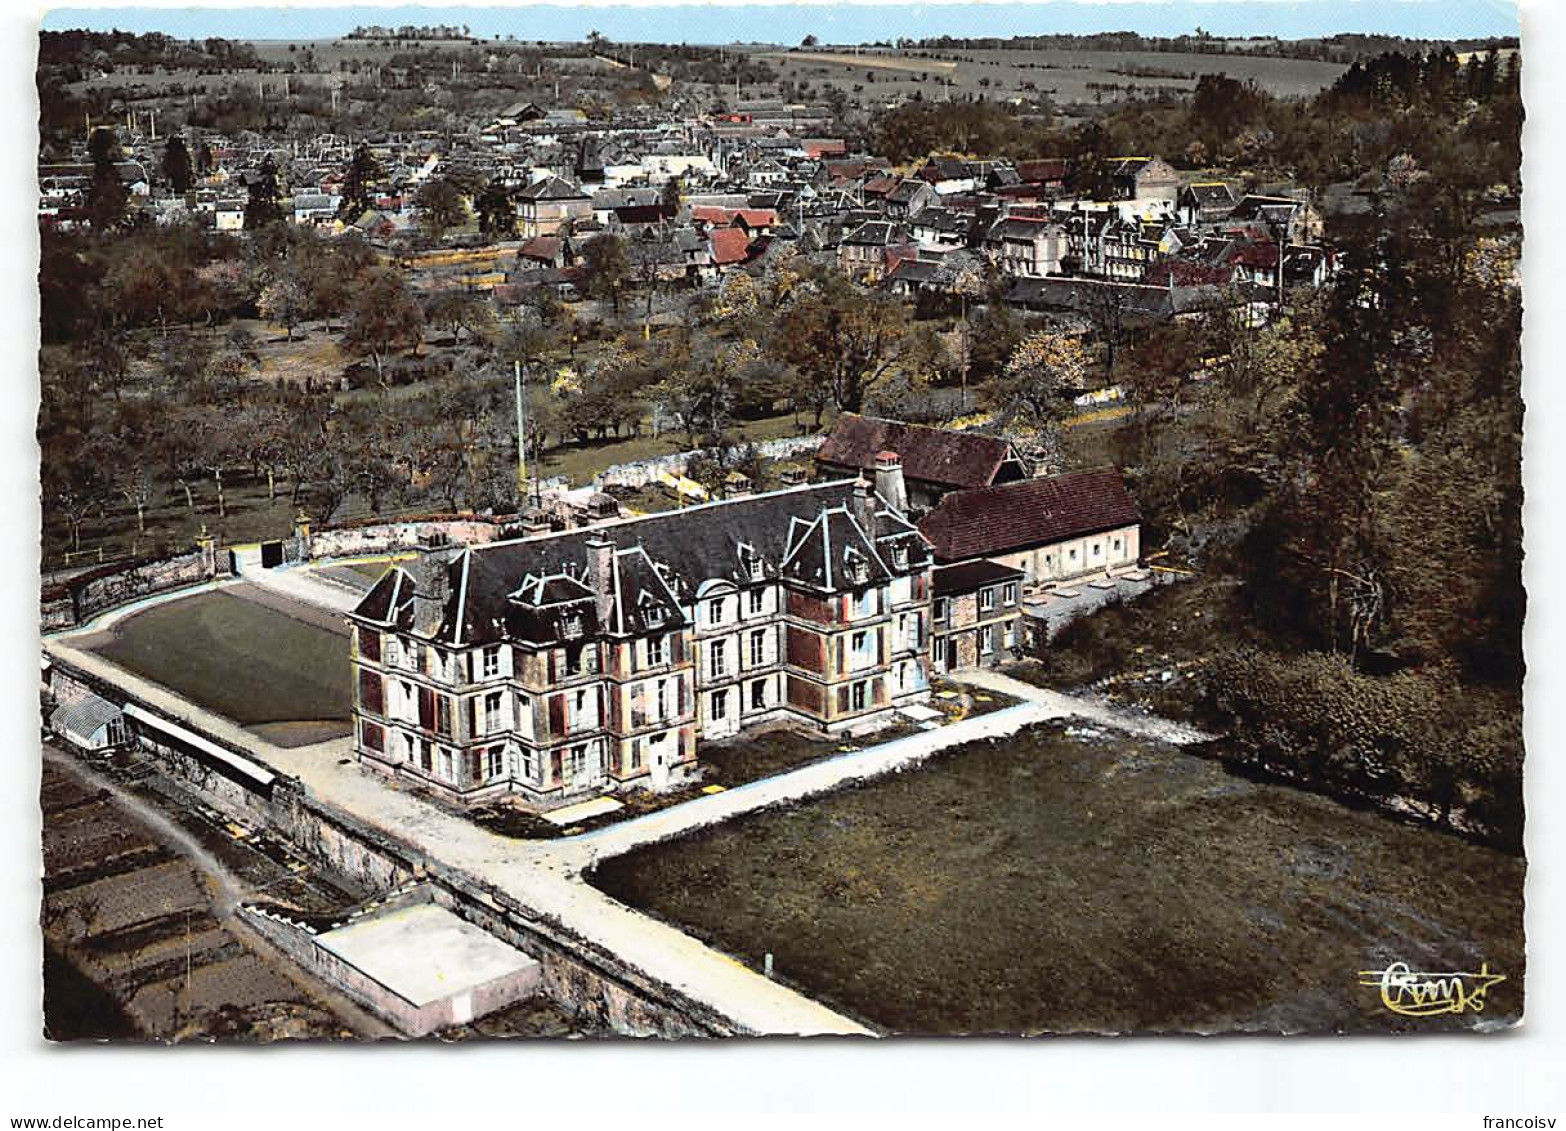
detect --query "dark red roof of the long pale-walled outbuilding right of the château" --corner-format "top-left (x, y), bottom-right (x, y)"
top-left (919, 467), bottom-right (1140, 561)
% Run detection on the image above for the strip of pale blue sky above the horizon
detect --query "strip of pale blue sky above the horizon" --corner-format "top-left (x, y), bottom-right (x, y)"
top-left (42, 0), bottom-right (1517, 44)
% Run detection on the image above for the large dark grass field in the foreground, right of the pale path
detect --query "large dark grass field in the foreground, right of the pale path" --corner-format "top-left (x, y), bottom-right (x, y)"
top-left (595, 727), bottom-right (1524, 1032)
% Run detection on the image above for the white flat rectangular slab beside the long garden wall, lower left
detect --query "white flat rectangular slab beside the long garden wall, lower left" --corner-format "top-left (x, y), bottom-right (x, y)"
top-left (316, 904), bottom-right (539, 1007)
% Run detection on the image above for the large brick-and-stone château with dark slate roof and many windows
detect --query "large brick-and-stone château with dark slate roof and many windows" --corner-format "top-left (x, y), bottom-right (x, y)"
top-left (349, 470), bottom-right (930, 805)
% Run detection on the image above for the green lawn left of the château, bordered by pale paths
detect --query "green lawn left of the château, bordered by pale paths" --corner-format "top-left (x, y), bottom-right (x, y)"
top-left (89, 591), bottom-right (352, 741)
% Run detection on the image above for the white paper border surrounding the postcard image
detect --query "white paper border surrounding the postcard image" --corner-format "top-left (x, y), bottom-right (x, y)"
top-left (0, 0), bottom-right (1566, 1128)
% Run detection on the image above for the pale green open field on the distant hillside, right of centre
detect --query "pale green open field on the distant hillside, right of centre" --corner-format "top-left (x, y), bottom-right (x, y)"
top-left (763, 49), bottom-right (1344, 105)
